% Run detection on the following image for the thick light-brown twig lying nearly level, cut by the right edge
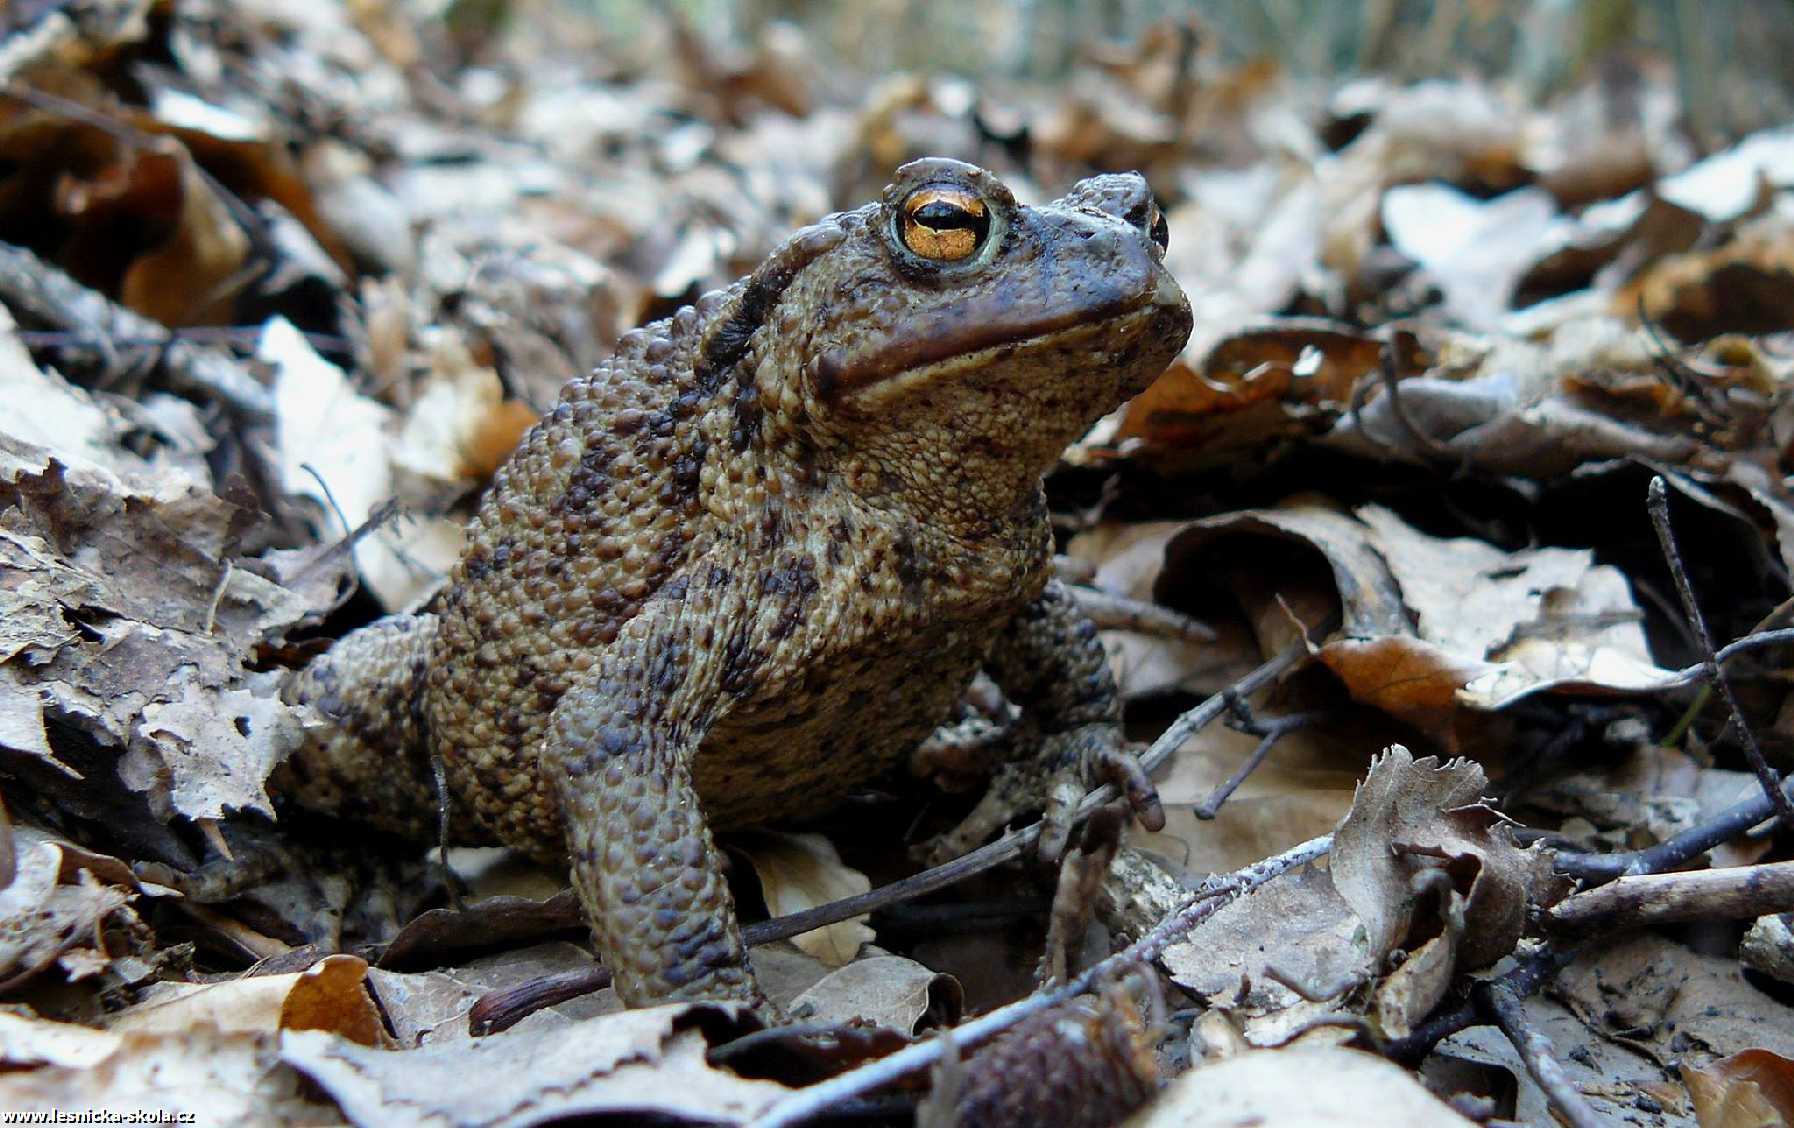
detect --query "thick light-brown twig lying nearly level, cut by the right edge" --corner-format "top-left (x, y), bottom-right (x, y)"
top-left (1543, 861), bottom-right (1794, 933)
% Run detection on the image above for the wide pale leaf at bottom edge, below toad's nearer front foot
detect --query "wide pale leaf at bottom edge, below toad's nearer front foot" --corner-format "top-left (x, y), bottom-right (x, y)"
top-left (280, 1004), bottom-right (791, 1128)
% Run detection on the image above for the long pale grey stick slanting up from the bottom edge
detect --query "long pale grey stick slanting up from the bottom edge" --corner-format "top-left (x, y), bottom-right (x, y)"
top-left (750, 834), bottom-right (1333, 1128)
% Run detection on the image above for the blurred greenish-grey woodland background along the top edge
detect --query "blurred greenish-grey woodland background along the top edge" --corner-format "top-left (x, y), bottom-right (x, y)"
top-left (534, 0), bottom-right (1794, 143)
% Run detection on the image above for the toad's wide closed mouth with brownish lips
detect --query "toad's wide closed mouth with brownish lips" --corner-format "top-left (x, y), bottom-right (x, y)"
top-left (814, 269), bottom-right (1191, 402)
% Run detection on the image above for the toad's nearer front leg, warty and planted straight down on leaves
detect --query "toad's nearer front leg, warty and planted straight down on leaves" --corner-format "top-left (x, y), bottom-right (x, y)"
top-left (542, 601), bottom-right (771, 1013)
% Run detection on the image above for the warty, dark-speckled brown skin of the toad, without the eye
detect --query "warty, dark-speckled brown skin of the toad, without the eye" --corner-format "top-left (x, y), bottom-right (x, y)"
top-left (289, 160), bottom-right (1189, 1004)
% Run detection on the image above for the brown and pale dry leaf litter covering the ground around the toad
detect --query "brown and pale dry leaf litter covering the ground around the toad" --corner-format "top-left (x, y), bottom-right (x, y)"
top-left (0, 0), bottom-right (1794, 1128)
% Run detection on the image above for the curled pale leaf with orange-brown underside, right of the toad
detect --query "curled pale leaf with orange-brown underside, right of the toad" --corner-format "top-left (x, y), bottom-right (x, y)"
top-left (1154, 497), bottom-right (1676, 746)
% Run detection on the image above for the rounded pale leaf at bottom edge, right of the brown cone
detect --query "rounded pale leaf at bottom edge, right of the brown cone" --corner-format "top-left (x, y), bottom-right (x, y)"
top-left (1123, 1046), bottom-right (1471, 1128)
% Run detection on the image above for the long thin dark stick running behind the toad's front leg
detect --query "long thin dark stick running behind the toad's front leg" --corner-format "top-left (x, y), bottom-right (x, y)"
top-left (468, 622), bottom-right (1333, 1031)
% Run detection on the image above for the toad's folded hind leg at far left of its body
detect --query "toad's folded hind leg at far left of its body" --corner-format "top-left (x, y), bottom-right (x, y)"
top-left (274, 615), bottom-right (440, 841)
